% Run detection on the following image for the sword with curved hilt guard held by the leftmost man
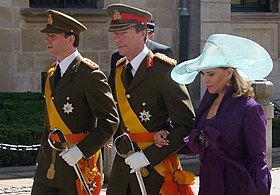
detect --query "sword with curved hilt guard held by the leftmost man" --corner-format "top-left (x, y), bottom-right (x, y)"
top-left (48, 128), bottom-right (93, 195)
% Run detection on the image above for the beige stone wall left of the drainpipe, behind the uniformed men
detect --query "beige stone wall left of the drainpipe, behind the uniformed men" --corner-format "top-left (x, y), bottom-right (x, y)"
top-left (0, 0), bottom-right (178, 92)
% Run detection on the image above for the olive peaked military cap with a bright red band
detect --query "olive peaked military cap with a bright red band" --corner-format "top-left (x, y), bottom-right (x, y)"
top-left (107, 3), bottom-right (152, 32)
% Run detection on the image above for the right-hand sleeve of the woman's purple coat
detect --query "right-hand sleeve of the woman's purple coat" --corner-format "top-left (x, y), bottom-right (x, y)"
top-left (244, 104), bottom-right (271, 195)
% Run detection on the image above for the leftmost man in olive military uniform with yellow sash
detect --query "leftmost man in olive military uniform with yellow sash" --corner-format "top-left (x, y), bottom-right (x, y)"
top-left (32, 10), bottom-right (119, 195)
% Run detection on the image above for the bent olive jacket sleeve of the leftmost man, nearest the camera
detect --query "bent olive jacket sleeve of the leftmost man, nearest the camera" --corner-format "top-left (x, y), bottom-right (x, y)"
top-left (77, 70), bottom-right (119, 158)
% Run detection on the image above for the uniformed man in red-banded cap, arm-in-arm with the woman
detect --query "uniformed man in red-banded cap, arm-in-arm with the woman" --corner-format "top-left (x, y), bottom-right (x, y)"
top-left (107, 4), bottom-right (194, 195)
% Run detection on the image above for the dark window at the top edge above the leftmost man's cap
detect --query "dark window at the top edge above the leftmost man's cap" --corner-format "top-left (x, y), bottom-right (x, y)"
top-left (29, 0), bottom-right (98, 8)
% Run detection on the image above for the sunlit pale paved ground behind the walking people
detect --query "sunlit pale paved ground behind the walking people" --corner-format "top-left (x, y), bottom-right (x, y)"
top-left (0, 148), bottom-right (280, 195)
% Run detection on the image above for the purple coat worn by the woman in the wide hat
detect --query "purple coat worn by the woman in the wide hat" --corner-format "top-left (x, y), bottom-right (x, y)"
top-left (184, 87), bottom-right (271, 195)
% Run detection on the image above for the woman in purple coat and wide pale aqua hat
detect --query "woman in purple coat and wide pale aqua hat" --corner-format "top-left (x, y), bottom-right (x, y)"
top-left (155, 34), bottom-right (272, 195)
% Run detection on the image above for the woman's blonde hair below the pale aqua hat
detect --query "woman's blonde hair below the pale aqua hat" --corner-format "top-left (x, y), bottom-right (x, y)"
top-left (231, 69), bottom-right (255, 97)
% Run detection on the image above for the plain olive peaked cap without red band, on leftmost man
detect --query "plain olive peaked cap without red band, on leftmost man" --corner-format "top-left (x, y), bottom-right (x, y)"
top-left (40, 9), bottom-right (87, 35)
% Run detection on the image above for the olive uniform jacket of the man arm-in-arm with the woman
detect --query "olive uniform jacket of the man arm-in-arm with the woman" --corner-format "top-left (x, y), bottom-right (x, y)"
top-left (107, 52), bottom-right (194, 195)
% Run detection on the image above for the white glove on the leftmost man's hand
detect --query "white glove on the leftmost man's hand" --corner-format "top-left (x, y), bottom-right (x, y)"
top-left (59, 145), bottom-right (83, 167)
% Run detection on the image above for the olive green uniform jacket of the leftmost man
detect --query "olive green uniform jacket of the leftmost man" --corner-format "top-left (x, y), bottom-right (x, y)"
top-left (34, 55), bottom-right (119, 189)
